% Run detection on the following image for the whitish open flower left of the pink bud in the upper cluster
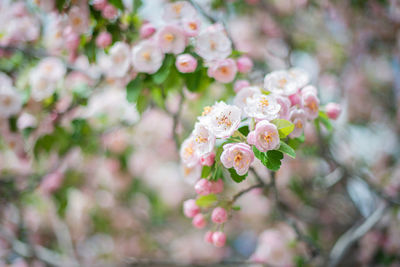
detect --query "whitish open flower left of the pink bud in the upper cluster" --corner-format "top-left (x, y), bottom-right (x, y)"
top-left (132, 41), bottom-right (164, 74)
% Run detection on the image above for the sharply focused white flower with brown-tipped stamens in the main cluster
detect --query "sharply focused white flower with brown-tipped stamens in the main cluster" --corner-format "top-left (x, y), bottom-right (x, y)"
top-left (201, 101), bottom-right (242, 138)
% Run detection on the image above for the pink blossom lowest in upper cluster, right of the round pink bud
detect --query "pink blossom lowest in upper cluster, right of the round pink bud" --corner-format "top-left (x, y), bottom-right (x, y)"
top-left (207, 58), bottom-right (237, 83)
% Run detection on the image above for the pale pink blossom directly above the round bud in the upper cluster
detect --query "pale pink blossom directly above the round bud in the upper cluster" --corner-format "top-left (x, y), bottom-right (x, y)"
top-left (157, 25), bottom-right (186, 54)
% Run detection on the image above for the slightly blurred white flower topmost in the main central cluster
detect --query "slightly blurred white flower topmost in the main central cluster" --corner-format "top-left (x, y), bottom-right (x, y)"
top-left (264, 70), bottom-right (299, 96)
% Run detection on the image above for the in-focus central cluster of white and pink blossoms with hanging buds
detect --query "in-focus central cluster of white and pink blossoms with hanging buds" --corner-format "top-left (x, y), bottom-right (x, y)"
top-left (180, 68), bottom-right (340, 246)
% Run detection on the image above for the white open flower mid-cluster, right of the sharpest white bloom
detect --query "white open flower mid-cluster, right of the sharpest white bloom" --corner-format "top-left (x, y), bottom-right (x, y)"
top-left (243, 94), bottom-right (281, 120)
